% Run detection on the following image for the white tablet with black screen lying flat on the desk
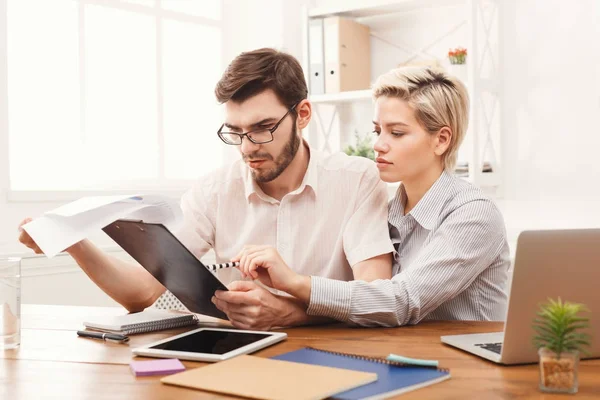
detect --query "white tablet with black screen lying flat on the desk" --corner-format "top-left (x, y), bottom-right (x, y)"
top-left (132, 328), bottom-right (287, 362)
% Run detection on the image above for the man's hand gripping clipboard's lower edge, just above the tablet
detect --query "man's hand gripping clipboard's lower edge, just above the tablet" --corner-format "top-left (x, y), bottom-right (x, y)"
top-left (212, 281), bottom-right (307, 330)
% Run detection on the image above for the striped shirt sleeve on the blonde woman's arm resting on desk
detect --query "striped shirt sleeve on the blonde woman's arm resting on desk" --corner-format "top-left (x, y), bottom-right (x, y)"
top-left (307, 200), bottom-right (505, 326)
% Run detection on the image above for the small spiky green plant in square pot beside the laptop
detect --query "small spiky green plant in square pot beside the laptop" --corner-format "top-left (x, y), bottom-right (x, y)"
top-left (533, 297), bottom-right (590, 393)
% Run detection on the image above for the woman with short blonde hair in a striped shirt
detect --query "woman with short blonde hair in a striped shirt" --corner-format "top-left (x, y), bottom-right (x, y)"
top-left (213, 68), bottom-right (509, 326)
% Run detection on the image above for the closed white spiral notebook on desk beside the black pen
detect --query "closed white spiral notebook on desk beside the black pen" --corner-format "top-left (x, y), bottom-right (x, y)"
top-left (83, 310), bottom-right (198, 335)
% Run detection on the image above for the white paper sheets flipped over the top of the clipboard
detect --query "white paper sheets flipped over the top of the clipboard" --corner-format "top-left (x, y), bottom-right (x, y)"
top-left (23, 195), bottom-right (183, 258)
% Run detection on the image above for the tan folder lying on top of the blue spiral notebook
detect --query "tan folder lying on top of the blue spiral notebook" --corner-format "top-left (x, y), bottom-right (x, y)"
top-left (160, 355), bottom-right (377, 400)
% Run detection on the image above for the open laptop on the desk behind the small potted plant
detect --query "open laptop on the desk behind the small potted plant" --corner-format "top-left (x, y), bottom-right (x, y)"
top-left (441, 229), bottom-right (600, 365)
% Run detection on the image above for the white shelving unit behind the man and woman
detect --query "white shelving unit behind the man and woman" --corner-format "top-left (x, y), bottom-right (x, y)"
top-left (302, 0), bottom-right (502, 196)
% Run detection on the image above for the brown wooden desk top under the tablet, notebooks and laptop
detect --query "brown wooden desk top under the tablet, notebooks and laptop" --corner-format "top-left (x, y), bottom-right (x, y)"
top-left (0, 305), bottom-right (600, 400)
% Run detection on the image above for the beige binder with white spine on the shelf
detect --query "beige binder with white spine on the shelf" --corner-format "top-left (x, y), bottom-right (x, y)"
top-left (323, 17), bottom-right (371, 93)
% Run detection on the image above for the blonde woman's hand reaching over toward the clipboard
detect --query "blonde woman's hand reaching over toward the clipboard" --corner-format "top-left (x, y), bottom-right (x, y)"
top-left (231, 245), bottom-right (310, 298)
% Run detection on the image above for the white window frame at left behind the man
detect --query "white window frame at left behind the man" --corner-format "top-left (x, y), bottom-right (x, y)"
top-left (0, 0), bottom-right (227, 203)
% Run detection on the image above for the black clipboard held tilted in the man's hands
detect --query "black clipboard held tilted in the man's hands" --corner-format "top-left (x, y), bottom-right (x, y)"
top-left (102, 220), bottom-right (228, 319)
